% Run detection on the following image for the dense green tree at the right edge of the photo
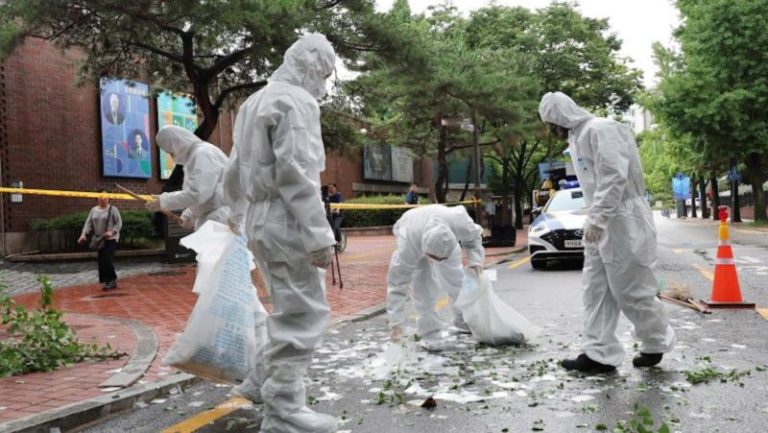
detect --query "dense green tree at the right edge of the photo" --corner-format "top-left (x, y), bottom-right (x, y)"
top-left (656, 0), bottom-right (768, 222)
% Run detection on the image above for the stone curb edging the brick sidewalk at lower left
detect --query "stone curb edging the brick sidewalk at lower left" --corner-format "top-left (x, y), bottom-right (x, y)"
top-left (0, 373), bottom-right (201, 433)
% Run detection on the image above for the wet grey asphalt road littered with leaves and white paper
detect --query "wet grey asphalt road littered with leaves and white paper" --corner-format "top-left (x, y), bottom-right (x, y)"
top-left (76, 213), bottom-right (768, 433)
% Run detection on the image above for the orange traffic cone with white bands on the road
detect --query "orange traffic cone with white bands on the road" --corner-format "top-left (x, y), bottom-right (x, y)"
top-left (705, 206), bottom-right (755, 308)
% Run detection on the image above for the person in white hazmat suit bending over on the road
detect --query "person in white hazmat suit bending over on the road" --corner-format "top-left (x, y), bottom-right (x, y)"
top-left (387, 204), bottom-right (485, 351)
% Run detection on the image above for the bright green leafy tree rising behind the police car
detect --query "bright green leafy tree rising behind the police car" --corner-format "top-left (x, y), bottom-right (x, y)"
top-left (466, 3), bottom-right (640, 228)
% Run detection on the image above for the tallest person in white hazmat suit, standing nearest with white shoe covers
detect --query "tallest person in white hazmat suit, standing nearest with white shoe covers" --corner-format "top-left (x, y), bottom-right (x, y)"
top-left (223, 33), bottom-right (337, 433)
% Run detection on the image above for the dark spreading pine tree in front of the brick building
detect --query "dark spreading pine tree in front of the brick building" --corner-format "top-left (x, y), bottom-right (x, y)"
top-left (0, 0), bottom-right (414, 185)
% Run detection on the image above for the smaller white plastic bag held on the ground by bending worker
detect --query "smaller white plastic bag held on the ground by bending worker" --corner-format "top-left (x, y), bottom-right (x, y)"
top-left (456, 270), bottom-right (540, 344)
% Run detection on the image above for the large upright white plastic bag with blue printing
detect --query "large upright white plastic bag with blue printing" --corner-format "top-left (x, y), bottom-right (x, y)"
top-left (163, 221), bottom-right (267, 384)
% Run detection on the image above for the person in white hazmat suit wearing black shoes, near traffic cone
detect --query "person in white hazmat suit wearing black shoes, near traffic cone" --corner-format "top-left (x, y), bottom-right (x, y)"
top-left (539, 92), bottom-right (675, 373)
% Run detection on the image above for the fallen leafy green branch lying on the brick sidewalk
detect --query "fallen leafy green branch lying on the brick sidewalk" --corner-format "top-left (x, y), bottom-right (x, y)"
top-left (0, 275), bottom-right (126, 377)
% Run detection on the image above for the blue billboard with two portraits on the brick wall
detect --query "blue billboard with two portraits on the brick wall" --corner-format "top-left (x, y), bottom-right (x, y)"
top-left (100, 79), bottom-right (152, 179)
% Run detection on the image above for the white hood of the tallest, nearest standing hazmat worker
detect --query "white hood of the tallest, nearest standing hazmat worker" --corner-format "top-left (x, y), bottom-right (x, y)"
top-left (271, 33), bottom-right (336, 99)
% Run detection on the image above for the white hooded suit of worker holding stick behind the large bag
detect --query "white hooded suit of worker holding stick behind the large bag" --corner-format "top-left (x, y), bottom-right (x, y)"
top-left (157, 125), bottom-right (228, 230)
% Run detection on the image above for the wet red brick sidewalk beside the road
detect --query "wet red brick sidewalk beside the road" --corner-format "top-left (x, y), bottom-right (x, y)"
top-left (0, 230), bottom-right (526, 426)
